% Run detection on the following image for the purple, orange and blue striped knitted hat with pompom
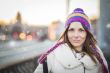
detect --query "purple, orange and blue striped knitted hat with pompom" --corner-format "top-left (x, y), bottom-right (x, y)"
top-left (65, 8), bottom-right (91, 30)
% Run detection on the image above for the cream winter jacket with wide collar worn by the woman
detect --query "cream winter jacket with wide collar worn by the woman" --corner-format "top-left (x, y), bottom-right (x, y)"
top-left (34, 44), bottom-right (105, 73)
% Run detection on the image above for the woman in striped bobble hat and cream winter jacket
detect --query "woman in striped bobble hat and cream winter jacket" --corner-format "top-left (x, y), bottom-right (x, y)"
top-left (34, 8), bottom-right (109, 73)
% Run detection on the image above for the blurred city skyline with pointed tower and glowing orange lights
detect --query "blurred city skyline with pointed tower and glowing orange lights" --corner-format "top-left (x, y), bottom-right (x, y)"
top-left (0, 12), bottom-right (48, 41)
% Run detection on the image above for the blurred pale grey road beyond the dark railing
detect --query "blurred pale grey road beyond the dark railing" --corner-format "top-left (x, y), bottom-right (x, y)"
top-left (0, 40), bottom-right (54, 69)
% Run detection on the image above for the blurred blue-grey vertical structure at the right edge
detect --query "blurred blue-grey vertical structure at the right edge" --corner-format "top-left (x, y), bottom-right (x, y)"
top-left (97, 0), bottom-right (110, 49)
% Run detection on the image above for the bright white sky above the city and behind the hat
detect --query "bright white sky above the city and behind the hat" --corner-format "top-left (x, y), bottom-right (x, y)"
top-left (0, 0), bottom-right (99, 25)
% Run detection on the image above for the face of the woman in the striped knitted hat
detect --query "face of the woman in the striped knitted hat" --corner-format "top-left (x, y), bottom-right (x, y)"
top-left (67, 22), bottom-right (87, 48)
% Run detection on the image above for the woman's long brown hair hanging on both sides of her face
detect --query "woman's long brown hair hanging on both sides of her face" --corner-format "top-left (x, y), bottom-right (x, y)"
top-left (60, 25), bottom-right (97, 63)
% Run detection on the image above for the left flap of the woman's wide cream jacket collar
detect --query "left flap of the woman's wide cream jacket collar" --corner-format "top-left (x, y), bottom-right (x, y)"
top-left (54, 44), bottom-right (81, 68)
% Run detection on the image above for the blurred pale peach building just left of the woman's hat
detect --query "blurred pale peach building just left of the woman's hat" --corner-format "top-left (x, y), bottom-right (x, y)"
top-left (48, 20), bottom-right (64, 41)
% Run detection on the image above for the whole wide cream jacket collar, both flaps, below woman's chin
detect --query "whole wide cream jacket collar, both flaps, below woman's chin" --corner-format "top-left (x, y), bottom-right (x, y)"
top-left (54, 44), bottom-right (96, 68)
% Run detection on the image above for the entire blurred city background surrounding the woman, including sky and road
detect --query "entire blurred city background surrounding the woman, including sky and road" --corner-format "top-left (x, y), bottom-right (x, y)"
top-left (0, 0), bottom-right (110, 73)
